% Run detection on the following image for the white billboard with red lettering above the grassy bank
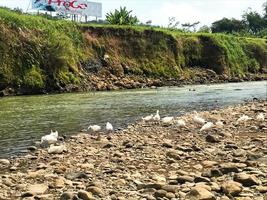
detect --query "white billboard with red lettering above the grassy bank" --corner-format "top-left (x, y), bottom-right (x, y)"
top-left (32, 0), bottom-right (102, 17)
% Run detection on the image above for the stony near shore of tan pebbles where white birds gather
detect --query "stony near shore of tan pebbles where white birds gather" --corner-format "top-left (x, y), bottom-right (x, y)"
top-left (0, 101), bottom-right (267, 200)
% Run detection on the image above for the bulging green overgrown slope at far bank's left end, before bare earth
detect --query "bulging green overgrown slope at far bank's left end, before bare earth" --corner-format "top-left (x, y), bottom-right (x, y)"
top-left (0, 8), bottom-right (83, 90)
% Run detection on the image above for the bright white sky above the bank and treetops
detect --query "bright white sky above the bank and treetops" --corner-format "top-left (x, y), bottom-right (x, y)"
top-left (0, 0), bottom-right (267, 26)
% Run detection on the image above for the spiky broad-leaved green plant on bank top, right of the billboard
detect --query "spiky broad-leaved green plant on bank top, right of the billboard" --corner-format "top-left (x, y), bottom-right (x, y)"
top-left (106, 7), bottom-right (139, 25)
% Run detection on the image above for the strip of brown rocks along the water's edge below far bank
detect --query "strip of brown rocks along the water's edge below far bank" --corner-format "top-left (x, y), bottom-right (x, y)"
top-left (0, 68), bottom-right (267, 97)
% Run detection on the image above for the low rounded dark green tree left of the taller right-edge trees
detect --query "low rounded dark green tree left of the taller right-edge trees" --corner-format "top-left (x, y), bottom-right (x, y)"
top-left (211, 18), bottom-right (247, 33)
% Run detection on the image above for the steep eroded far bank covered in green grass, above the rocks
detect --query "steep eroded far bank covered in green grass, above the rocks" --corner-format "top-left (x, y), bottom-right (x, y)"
top-left (0, 9), bottom-right (267, 93)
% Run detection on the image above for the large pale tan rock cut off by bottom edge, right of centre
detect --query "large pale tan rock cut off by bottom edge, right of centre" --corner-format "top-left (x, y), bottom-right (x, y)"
top-left (186, 187), bottom-right (216, 200)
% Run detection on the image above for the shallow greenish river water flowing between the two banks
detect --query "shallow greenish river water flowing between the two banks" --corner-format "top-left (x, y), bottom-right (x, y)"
top-left (0, 81), bottom-right (267, 158)
